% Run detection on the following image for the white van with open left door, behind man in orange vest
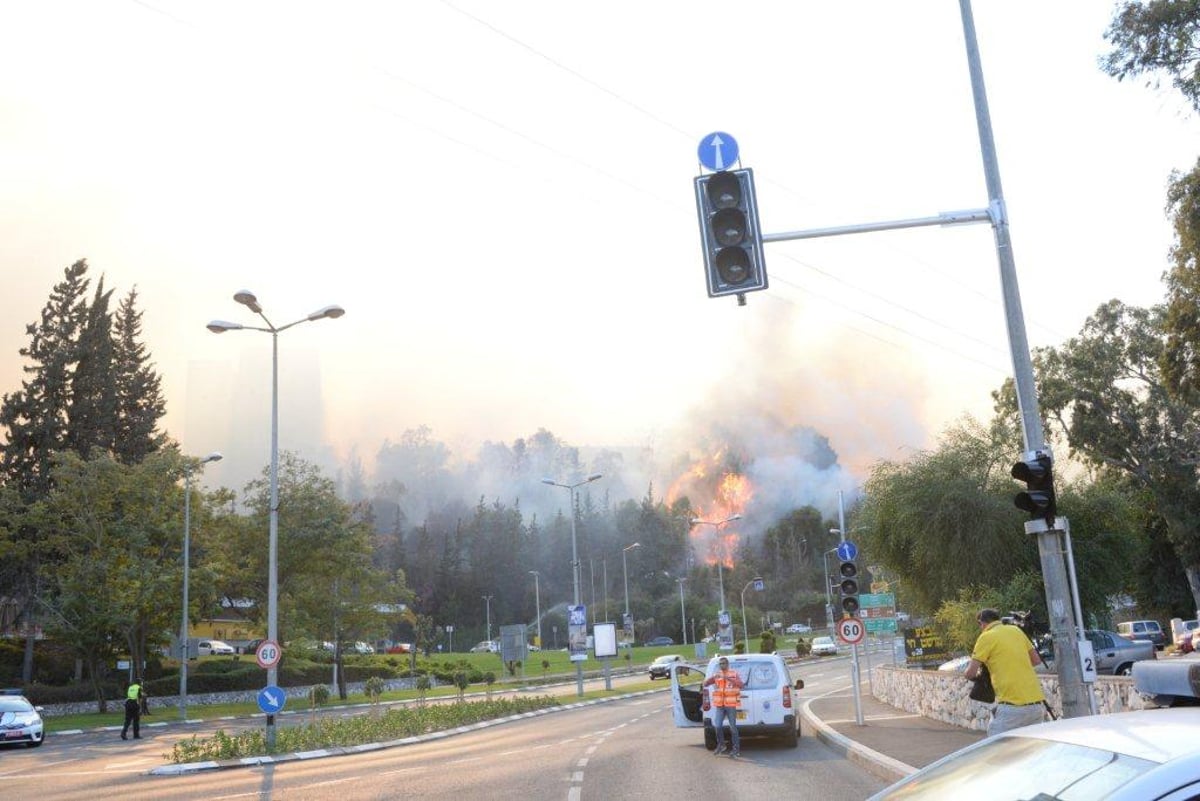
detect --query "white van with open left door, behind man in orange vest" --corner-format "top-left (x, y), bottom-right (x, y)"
top-left (671, 654), bottom-right (804, 751)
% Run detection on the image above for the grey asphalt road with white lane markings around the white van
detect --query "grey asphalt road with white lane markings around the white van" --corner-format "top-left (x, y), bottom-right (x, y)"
top-left (0, 658), bottom-right (882, 801)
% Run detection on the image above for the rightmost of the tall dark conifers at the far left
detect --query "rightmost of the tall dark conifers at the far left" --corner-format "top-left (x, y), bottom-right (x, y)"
top-left (112, 288), bottom-right (167, 464)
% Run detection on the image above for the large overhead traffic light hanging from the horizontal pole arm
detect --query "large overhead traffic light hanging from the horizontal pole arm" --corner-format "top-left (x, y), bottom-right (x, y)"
top-left (696, 169), bottom-right (767, 297)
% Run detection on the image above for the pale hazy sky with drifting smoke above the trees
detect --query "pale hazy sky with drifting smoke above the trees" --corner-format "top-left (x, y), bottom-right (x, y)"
top-left (0, 0), bottom-right (1200, 520)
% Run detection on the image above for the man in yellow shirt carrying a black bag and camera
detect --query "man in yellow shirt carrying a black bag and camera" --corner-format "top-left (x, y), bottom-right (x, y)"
top-left (965, 609), bottom-right (1045, 736)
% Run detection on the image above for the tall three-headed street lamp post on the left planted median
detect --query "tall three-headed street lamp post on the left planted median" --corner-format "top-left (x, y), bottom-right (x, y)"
top-left (208, 289), bottom-right (346, 749)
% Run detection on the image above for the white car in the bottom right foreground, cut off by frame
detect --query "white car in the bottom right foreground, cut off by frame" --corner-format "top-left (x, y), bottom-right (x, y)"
top-left (870, 658), bottom-right (1200, 801)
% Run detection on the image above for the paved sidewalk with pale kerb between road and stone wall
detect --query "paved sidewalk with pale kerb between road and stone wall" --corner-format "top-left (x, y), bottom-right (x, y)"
top-left (800, 681), bottom-right (986, 782)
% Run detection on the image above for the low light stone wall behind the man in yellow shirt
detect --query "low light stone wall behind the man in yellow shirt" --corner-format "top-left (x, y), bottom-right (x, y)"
top-left (871, 664), bottom-right (1147, 731)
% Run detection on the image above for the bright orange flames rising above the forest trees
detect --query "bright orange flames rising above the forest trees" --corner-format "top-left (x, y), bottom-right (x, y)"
top-left (667, 452), bottom-right (754, 567)
